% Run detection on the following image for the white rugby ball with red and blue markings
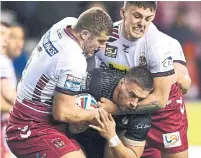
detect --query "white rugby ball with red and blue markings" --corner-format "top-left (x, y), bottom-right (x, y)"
top-left (75, 93), bottom-right (98, 110)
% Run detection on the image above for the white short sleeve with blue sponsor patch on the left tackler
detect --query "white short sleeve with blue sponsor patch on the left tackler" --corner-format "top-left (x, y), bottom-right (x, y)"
top-left (56, 52), bottom-right (87, 93)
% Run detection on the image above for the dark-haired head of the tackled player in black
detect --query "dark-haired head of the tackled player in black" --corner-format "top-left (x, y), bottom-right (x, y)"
top-left (117, 66), bottom-right (154, 111)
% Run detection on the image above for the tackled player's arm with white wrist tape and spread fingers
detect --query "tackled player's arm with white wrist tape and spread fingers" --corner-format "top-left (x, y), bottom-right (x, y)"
top-left (90, 111), bottom-right (151, 158)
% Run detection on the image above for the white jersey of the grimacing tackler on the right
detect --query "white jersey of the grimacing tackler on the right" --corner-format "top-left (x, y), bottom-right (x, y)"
top-left (96, 21), bottom-right (174, 77)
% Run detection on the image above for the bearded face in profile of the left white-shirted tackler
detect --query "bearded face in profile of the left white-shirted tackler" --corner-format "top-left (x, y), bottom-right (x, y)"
top-left (85, 32), bottom-right (109, 57)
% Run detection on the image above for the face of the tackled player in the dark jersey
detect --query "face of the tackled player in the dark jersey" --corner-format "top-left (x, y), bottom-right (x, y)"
top-left (118, 79), bottom-right (151, 112)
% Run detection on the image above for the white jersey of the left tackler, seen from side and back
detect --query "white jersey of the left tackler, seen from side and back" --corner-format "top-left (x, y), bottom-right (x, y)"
top-left (17, 18), bottom-right (87, 107)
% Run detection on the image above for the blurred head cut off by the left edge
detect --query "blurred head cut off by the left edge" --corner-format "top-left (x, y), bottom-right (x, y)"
top-left (0, 22), bottom-right (10, 53)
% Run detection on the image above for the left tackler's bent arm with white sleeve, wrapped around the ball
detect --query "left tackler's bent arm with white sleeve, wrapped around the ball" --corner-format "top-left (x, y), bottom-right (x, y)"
top-left (52, 53), bottom-right (98, 123)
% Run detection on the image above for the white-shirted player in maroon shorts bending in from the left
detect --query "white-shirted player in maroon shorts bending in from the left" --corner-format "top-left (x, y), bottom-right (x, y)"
top-left (6, 8), bottom-right (112, 158)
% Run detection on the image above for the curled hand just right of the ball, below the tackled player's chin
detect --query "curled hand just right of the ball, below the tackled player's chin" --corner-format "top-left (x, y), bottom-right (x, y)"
top-left (98, 98), bottom-right (120, 114)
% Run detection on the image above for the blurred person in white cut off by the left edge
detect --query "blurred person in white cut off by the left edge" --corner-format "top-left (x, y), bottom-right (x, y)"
top-left (0, 22), bottom-right (17, 158)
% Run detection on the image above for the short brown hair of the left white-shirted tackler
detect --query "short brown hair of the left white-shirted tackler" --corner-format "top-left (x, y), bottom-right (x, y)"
top-left (75, 7), bottom-right (113, 35)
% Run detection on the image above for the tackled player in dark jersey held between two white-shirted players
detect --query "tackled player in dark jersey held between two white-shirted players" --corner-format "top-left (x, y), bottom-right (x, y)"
top-left (72, 67), bottom-right (153, 158)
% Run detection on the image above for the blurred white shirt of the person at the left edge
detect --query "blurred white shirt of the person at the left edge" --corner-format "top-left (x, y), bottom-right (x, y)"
top-left (0, 53), bottom-right (17, 89)
